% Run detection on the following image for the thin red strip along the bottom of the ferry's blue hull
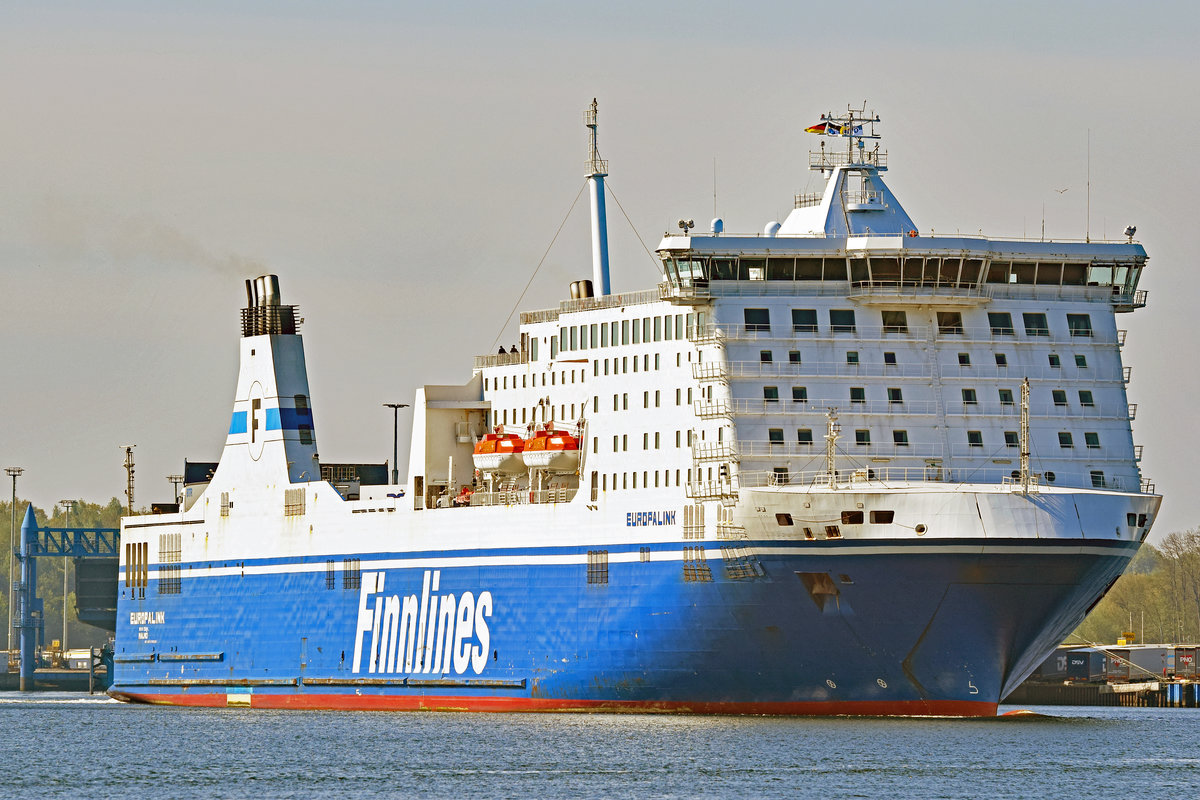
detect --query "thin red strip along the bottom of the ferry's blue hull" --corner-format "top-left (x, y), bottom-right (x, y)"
top-left (110, 692), bottom-right (998, 717)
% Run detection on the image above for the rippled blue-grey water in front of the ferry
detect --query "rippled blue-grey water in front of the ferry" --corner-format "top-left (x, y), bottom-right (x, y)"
top-left (0, 693), bottom-right (1200, 800)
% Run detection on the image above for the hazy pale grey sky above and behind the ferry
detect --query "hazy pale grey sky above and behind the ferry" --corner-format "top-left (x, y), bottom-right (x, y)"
top-left (0, 1), bottom-right (1200, 537)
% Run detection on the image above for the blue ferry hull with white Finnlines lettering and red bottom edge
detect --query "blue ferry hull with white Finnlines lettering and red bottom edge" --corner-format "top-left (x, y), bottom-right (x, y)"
top-left (112, 539), bottom-right (1138, 715)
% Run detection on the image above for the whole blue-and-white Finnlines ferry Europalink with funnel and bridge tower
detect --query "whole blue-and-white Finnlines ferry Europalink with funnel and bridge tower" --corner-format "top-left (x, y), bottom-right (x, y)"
top-left (110, 102), bottom-right (1160, 716)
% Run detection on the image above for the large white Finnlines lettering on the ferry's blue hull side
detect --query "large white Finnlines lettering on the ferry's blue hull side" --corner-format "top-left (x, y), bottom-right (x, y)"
top-left (353, 570), bottom-right (492, 675)
